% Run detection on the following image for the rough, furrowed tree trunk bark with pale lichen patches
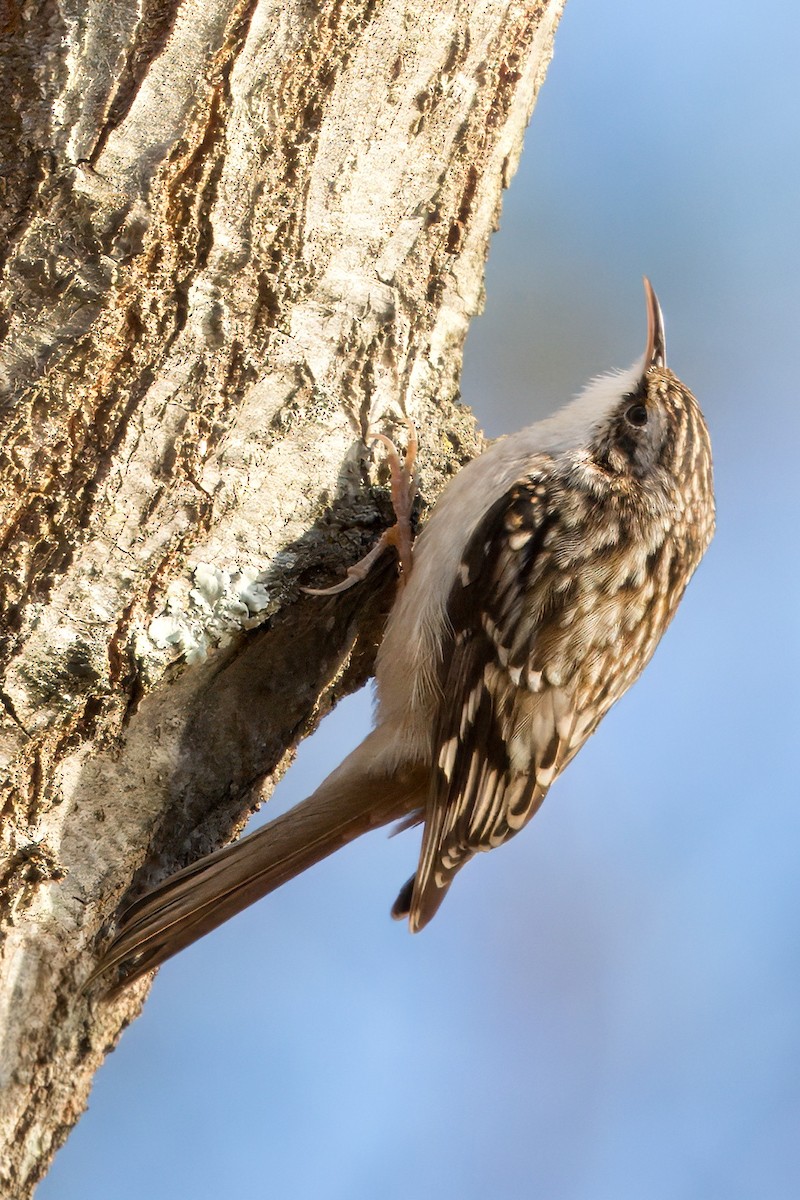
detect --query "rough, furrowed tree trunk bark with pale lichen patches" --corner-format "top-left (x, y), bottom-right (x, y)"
top-left (0, 0), bottom-right (563, 1196)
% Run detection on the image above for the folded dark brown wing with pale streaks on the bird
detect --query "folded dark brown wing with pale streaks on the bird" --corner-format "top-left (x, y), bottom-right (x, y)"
top-left (407, 474), bottom-right (577, 930)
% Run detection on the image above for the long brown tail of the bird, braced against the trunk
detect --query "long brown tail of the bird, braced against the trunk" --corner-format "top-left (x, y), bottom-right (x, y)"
top-left (92, 738), bottom-right (427, 990)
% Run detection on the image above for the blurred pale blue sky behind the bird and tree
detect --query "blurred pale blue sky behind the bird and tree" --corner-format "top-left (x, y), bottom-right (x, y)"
top-left (43, 0), bottom-right (800, 1200)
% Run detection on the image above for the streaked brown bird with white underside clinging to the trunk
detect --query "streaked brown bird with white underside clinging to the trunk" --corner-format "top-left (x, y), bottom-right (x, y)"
top-left (92, 277), bottom-right (715, 990)
